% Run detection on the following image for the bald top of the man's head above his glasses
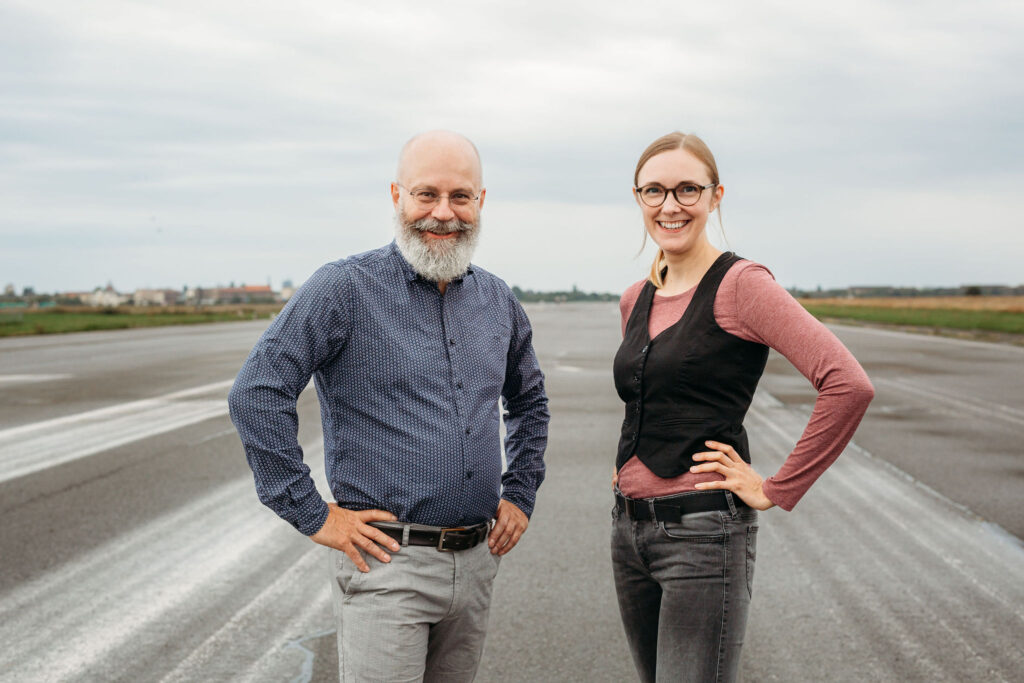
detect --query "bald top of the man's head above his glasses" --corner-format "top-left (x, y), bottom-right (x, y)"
top-left (395, 130), bottom-right (483, 190)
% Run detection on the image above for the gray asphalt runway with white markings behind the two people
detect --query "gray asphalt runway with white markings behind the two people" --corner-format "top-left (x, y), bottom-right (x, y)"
top-left (0, 304), bottom-right (1024, 682)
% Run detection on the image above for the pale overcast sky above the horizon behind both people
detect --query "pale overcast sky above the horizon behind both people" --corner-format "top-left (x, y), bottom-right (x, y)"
top-left (0, 0), bottom-right (1024, 292)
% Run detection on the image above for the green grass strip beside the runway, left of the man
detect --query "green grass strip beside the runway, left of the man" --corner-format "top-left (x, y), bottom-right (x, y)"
top-left (0, 309), bottom-right (272, 337)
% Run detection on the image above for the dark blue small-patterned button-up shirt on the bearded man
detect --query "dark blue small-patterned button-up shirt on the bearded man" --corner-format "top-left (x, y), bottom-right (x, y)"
top-left (228, 243), bottom-right (548, 535)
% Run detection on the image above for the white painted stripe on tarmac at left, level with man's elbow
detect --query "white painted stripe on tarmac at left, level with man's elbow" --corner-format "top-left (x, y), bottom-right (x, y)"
top-left (0, 380), bottom-right (233, 482)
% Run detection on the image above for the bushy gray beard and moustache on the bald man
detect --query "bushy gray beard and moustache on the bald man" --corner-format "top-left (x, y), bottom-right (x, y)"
top-left (394, 210), bottom-right (480, 283)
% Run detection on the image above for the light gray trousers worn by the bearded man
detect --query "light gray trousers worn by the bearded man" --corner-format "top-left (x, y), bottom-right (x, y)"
top-left (330, 543), bottom-right (501, 683)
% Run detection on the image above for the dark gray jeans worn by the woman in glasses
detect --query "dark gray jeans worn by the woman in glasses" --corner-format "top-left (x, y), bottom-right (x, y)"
top-left (611, 494), bottom-right (758, 683)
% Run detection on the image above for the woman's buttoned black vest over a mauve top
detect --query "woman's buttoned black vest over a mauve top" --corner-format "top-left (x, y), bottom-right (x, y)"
top-left (614, 252), bottom-right (768, 477)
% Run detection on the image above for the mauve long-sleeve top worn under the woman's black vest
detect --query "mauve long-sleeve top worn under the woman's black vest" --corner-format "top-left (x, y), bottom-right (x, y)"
top-left (618, 260), bottom-right (874, 510)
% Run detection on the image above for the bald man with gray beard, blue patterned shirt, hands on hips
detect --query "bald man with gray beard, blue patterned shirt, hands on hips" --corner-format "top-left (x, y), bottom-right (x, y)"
top-left (228, 131), bottom-right (548, 681)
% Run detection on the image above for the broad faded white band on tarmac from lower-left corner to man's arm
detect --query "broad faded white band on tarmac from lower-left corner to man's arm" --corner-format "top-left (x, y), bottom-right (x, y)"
top-left (0, 442), bottom-right (326, 681)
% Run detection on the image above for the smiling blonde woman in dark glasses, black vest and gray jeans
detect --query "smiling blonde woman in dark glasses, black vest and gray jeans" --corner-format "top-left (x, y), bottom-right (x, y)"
top-left (611, 132), bottom-right (874, 682)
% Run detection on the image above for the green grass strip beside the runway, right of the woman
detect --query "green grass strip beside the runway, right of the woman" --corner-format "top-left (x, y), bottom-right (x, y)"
top-left (801, 301), bottom-right (1024, 334)
